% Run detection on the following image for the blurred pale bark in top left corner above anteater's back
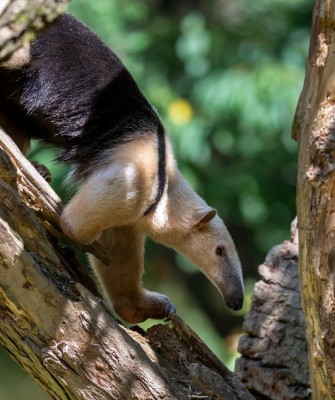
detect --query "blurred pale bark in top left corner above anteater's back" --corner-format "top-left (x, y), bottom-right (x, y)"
top-left (0, 0), bottom-right (69, 62)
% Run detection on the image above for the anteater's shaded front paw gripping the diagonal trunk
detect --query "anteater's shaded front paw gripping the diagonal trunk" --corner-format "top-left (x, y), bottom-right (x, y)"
top-left (114, 290), bottom-right (176, 324)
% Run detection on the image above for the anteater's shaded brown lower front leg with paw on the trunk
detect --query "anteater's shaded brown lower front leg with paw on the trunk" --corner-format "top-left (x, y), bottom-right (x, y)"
top-left (90, 225), bottom-right (175, 323)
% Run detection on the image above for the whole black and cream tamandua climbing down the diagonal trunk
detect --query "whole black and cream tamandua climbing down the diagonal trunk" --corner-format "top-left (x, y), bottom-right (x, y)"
top-left (0, 14), bottom-right (247, 323)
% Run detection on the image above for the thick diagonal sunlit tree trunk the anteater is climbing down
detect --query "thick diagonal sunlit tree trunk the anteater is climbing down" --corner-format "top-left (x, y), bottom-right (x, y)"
top-left (0, 0), bottom-right (253, 400)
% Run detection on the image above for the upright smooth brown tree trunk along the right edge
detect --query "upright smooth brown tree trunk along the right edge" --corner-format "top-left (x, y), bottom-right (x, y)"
top-left (292, 0), bottom-right (335, 400)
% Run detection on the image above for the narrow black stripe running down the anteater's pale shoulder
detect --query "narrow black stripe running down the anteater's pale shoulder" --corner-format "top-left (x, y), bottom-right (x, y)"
top-left (144, 121), bottom-right (166, 215)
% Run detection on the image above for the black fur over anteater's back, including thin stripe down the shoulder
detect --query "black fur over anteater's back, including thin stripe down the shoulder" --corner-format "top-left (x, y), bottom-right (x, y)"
top-left (0, 14), bottom-right (166, 214)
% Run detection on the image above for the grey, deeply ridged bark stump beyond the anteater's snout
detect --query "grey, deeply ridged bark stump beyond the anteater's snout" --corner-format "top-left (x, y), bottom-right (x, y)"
top-left (235, 222), bottom-right (310, 400)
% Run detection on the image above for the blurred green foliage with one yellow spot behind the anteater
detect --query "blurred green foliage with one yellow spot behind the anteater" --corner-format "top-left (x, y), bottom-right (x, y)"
top-left (0, 0), bottom-right (312, 400)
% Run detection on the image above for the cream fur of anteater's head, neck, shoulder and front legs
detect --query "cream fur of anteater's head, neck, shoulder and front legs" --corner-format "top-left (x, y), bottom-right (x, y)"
top-left (61, 135), bottom-right (243, 323)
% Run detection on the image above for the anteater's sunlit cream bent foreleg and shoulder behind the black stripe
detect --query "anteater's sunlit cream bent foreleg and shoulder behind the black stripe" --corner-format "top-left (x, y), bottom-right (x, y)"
top-left (61, 138), bottom-right (162, 244)
